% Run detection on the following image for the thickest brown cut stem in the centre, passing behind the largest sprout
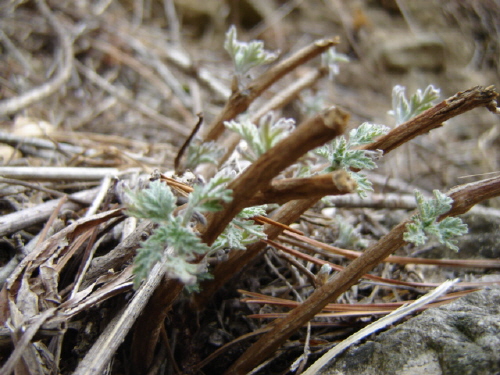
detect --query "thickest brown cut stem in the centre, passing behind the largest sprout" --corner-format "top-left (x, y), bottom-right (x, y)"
top-left (133, 107), bottom-right (349, 368)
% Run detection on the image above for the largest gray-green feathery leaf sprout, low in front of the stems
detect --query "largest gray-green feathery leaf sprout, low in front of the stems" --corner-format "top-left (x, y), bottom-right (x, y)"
top-left (126, 171), bottom-right (265, 291)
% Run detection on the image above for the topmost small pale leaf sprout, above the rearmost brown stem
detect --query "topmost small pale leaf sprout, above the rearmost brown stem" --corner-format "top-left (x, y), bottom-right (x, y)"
top-left (224, 25), bottom-right (278, 75)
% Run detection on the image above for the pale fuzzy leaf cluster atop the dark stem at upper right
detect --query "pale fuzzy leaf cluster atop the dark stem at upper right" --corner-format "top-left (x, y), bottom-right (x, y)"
top-left (389, 85), bottom-right (439, 125)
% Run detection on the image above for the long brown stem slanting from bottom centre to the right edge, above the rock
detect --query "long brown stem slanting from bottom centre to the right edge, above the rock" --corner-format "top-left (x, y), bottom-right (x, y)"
top-left (226, 177), bottom-right (500, 375)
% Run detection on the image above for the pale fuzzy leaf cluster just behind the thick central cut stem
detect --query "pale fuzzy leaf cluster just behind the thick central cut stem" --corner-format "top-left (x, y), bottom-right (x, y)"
top-left (224, 115), bottom-right (295, 162)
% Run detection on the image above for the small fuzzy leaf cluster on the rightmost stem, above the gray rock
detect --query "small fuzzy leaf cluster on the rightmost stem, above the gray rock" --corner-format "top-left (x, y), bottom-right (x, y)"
top-left (403, 190), bottom-right (467, 251)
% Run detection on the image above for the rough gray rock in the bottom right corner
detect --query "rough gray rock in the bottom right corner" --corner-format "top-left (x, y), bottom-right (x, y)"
top-left (320, 287), bottom-right (500, 375)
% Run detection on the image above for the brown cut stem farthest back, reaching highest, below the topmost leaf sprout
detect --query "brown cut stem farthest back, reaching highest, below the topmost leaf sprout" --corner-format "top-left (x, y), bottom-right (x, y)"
top-left (204, 37), bottom-right (340, 142)
